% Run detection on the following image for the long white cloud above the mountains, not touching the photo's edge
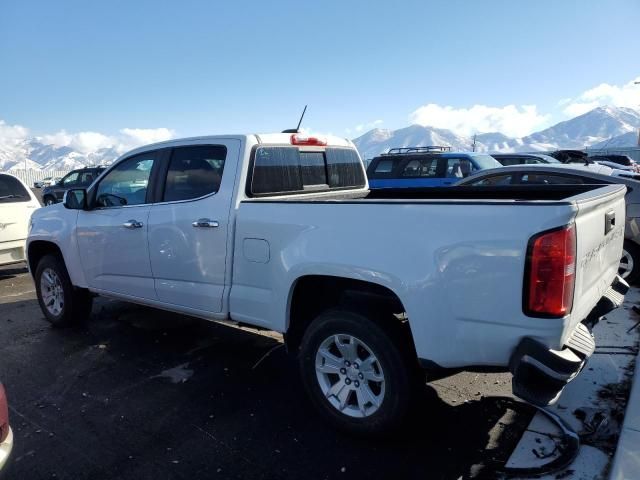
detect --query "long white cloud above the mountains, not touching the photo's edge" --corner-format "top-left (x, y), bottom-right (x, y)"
top-left (409, 103), bottom-right (550, 137)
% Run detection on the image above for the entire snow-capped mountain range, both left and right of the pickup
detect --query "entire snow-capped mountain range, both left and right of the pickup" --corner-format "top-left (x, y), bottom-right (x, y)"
top-left (0, 107), bottom-right (640, 171)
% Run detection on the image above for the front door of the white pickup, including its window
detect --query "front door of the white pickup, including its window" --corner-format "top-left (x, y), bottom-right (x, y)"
top-left (77, 151), bottom-right (159, 300)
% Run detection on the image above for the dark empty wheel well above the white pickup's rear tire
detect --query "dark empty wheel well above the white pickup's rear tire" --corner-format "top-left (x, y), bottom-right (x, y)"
top-left (285, 275), bottom-right (415, 352)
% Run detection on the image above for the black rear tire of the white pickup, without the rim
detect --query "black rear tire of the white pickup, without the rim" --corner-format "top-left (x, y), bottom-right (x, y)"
top-left (299, 308), bottom-right (418, 435)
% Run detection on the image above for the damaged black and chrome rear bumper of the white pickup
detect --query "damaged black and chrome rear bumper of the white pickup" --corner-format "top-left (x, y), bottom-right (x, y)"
top-left (509, 276), bottom-right (629, 406)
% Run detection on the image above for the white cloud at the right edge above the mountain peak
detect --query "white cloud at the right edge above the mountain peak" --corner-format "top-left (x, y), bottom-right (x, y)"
top-left (563, 77), bottom-right (640, 117)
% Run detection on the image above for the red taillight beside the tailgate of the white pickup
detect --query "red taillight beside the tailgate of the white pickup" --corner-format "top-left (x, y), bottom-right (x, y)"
top-left (523, 225), bottom-right (576, 317)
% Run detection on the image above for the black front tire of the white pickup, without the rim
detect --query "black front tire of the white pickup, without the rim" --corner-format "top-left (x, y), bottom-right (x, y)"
top-left (34, 255), bottom-right (93, 327)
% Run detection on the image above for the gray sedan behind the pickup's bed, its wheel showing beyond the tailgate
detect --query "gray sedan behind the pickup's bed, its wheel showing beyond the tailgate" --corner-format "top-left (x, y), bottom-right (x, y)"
top-left (457, 164), bottom-right (640, 283)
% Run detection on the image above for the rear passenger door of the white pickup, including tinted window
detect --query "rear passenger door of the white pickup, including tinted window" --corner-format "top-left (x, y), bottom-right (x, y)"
top-left (149, 140), bottom-right (240, 313)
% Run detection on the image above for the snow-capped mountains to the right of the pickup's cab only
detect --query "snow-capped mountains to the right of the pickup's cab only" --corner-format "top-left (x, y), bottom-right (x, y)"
top-left (354, 107), bottom-right (640, 159)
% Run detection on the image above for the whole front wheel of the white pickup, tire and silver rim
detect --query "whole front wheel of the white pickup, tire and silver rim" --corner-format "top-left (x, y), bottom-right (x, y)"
top-left (35, 255), bottom-right (93, 327)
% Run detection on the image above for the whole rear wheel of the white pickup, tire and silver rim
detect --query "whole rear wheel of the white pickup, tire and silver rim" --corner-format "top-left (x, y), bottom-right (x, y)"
top-left (299, 309), bottom-right (414, 434)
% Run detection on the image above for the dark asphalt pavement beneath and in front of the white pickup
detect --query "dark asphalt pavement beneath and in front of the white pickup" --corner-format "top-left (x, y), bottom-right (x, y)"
top-left (0, 268), bottom-right (533, 480)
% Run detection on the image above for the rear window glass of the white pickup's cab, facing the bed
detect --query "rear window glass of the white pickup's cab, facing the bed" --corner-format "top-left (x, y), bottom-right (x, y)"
top-left (250, 147), bottom-right (365, 195)
